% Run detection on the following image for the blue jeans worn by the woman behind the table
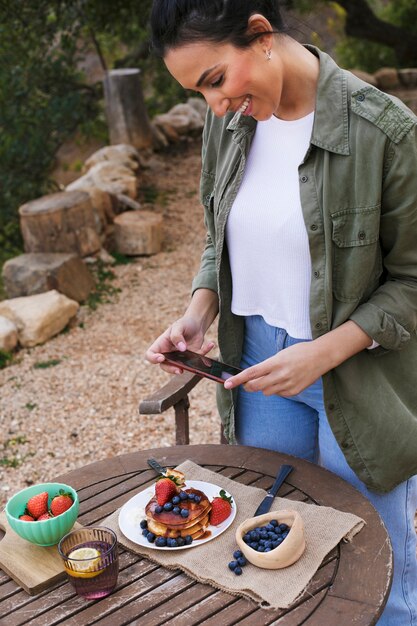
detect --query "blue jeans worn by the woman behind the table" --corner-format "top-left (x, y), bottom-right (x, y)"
top-left (236, 315), bottom-right (417, 626)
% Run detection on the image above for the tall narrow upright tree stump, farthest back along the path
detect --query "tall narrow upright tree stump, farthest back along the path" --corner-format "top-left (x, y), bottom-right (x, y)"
top-left (103, 68), bottom-right (153, 149)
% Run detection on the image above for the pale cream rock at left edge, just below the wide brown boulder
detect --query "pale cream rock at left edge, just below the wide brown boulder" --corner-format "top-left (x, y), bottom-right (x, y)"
top-left (0, 290), bottom-right (80, 348)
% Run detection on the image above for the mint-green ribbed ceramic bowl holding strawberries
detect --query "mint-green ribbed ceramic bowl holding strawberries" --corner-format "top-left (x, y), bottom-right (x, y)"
top-left (6, 483), bottom-right (80, 546)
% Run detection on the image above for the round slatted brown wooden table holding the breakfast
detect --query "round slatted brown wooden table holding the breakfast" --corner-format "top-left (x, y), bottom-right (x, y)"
top-left (0, 445), bottom-right (392, 626)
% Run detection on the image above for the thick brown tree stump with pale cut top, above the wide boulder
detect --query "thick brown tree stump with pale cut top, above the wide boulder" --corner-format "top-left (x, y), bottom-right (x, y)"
top-left (19, 191), bottom-right (101, 257)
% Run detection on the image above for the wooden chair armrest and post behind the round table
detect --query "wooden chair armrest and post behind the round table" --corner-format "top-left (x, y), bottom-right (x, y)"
top-left (139, 372), bottom-right (227, 446)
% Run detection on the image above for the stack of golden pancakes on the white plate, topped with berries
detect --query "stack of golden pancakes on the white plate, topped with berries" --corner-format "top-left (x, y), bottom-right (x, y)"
top-left (145, 488), bottom-right (211, 540)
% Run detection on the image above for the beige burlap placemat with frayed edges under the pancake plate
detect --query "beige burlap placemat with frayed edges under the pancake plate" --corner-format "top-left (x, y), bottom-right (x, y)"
top-left (103, 461), bottom-right (365, 609)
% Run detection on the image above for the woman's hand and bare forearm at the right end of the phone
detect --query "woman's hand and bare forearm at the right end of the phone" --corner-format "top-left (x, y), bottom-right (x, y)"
top-left (224, 320), bottom-right (372, 397)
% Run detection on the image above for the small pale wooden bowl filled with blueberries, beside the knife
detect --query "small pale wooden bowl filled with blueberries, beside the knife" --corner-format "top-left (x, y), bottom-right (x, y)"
top-left (236, 510), bottom-right (306, 569)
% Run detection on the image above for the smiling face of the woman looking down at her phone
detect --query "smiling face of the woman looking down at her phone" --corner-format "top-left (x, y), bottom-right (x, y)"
top-left (164, 40), bottom-right (282, 121)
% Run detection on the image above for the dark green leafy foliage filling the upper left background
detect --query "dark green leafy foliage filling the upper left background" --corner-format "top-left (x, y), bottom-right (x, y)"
top-left (0, 0), bottom-right (179, 270)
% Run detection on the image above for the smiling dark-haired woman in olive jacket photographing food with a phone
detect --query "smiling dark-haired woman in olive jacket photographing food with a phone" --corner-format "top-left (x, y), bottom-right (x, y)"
top-left (147, 0), bottom-right (417, 626)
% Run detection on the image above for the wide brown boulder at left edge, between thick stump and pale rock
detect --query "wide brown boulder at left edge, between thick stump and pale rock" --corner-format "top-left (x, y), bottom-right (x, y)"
top-left (3, 252), bottom-right (94, 302)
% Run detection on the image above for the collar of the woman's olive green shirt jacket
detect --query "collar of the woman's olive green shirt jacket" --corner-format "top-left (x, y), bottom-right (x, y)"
top-left (227, 45), bottom-right (350, 155)
